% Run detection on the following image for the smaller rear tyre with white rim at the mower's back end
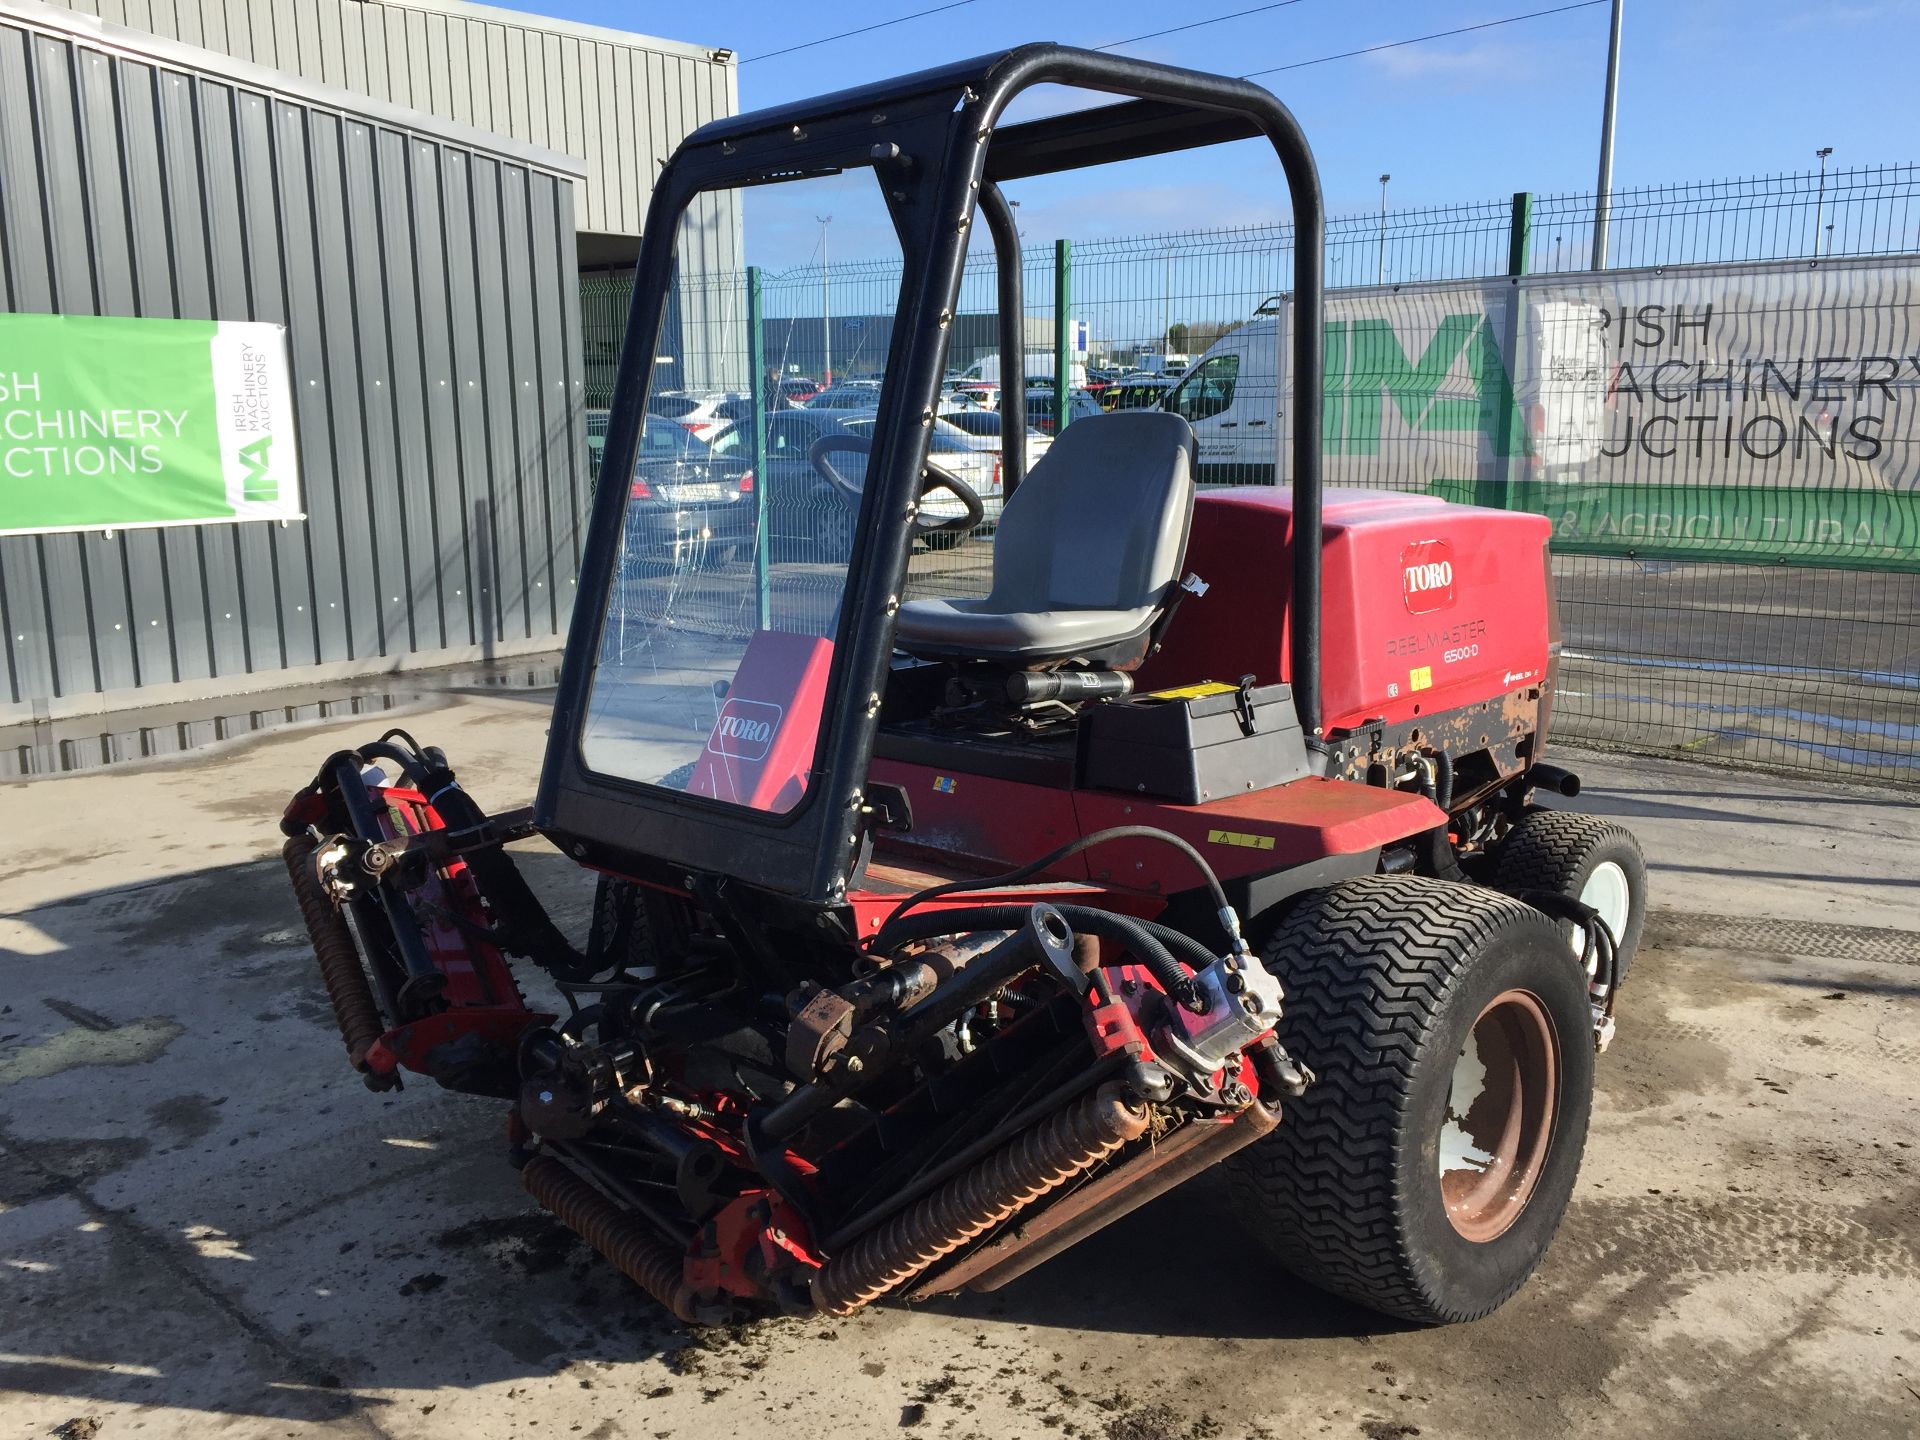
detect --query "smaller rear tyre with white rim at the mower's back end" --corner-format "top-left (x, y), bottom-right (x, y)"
top-left (1492, 808), bottom-right (1647, 979)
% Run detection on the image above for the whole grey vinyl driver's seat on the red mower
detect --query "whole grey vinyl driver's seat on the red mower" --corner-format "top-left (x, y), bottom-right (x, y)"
top-left (895, 411), bottom-right (1194, 670)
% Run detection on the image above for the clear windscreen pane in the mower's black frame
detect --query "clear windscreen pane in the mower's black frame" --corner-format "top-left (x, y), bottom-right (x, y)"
top-left (582, 169), bottom-right (900, 814)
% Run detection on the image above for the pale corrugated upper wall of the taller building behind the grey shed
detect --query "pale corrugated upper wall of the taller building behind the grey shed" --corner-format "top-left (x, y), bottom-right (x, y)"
top-left (56, 0), bottom-right (733, 234)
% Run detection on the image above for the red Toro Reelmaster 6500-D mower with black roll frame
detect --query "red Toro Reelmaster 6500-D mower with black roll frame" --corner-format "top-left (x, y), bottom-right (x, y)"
top-left (284, 46), bottom-right (1645, 1323)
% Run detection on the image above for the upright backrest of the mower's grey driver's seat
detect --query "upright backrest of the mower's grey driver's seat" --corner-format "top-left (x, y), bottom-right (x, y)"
top-left (989, 411), bottom-right (1194, 611)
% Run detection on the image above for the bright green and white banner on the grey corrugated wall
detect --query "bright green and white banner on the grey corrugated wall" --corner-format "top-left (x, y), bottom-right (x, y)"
top-left (0, 315), bottom-right (301, 534)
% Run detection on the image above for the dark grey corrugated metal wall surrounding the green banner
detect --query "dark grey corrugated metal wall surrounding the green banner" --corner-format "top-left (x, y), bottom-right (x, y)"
top-left (0, 0), bottom-right (588, 718)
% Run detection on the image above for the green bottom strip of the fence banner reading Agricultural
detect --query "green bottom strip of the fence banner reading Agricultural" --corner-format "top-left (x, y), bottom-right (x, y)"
top-left (1430, 480), bottom-right (1920, 572)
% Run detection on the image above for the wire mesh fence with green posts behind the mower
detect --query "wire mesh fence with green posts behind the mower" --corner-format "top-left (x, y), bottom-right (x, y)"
top-left (582, 165), bottom-right (1920, 781)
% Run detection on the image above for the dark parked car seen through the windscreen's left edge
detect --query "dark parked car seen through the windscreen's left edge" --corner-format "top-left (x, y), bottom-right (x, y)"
top-left (588, 411), bottom-right (755, 564)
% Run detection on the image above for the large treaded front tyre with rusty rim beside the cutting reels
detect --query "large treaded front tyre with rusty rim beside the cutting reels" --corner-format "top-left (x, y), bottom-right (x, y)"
top-left (1229, 876), bottom-right (1594, 1325)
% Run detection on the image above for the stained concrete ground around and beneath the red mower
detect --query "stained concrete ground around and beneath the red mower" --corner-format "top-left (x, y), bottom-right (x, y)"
top-left (0, 697), bottom-right (1920, 1440)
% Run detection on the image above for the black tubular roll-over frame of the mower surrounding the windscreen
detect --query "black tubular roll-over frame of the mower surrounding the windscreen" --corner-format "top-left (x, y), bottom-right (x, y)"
top-left (534, 44), bottom-right (1325, 906)
